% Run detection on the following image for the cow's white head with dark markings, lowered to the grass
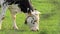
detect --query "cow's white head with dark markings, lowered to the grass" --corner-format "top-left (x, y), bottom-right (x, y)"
top-left (25, 10), bottom-right (41, 31)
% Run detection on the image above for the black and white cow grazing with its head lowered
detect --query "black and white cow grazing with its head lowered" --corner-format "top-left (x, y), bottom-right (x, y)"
top-left (0, 0), bottom-right (40, 31)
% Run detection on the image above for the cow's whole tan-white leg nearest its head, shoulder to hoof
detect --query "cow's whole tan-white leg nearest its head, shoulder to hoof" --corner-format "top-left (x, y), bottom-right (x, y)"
top-left (9, 5), bottom-right (18, 29)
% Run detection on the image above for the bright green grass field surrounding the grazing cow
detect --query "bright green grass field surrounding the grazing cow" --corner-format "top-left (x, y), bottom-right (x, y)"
top-left (0, 0), bottom-right (60, 34)
